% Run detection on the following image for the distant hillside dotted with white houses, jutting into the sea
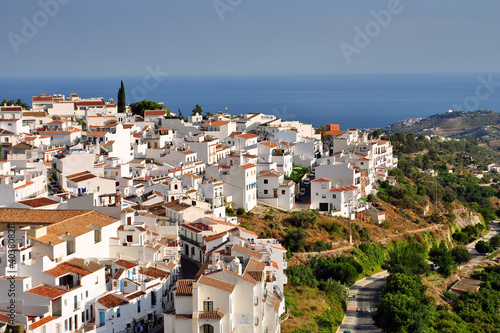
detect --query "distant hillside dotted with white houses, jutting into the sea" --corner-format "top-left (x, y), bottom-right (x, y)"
top-left (384, 110), bottom-right (500, 142)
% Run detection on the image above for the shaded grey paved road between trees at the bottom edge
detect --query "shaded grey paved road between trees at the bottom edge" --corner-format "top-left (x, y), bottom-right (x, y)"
top-left (337, 271), bottom-right (389, 333)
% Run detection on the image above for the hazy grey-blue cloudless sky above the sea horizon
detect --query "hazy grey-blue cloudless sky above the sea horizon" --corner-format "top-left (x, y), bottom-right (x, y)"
top-left (0, 0), bottom-right (500, 77)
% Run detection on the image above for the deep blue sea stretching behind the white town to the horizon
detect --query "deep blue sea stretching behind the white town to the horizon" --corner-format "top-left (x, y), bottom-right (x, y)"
top-left (0, 73), bottom-right (500, 129)
